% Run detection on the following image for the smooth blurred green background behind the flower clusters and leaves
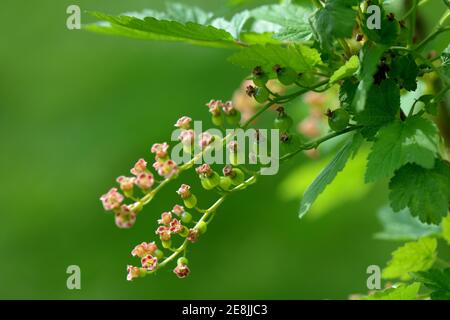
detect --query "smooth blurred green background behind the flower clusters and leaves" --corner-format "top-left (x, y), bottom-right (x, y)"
top-left (0, 0), bottom-right (446, 299)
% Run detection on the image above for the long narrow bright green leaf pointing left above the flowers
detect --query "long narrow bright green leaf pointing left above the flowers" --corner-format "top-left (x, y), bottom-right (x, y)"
top-left (85, 12), bottom-right (236, 47)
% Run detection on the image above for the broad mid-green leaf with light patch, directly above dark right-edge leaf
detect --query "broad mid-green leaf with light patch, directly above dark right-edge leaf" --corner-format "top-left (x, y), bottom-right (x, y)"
top-left (366, 115), bottom-right (439, 182)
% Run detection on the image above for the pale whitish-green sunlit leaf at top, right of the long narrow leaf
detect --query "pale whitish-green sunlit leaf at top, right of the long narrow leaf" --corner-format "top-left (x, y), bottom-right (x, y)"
top-left (251, 3), bottom-right (312, 42)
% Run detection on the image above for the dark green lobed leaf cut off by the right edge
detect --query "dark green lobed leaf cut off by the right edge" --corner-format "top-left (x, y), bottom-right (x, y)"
top-left (389, 160), bottom-right (450, 224)
